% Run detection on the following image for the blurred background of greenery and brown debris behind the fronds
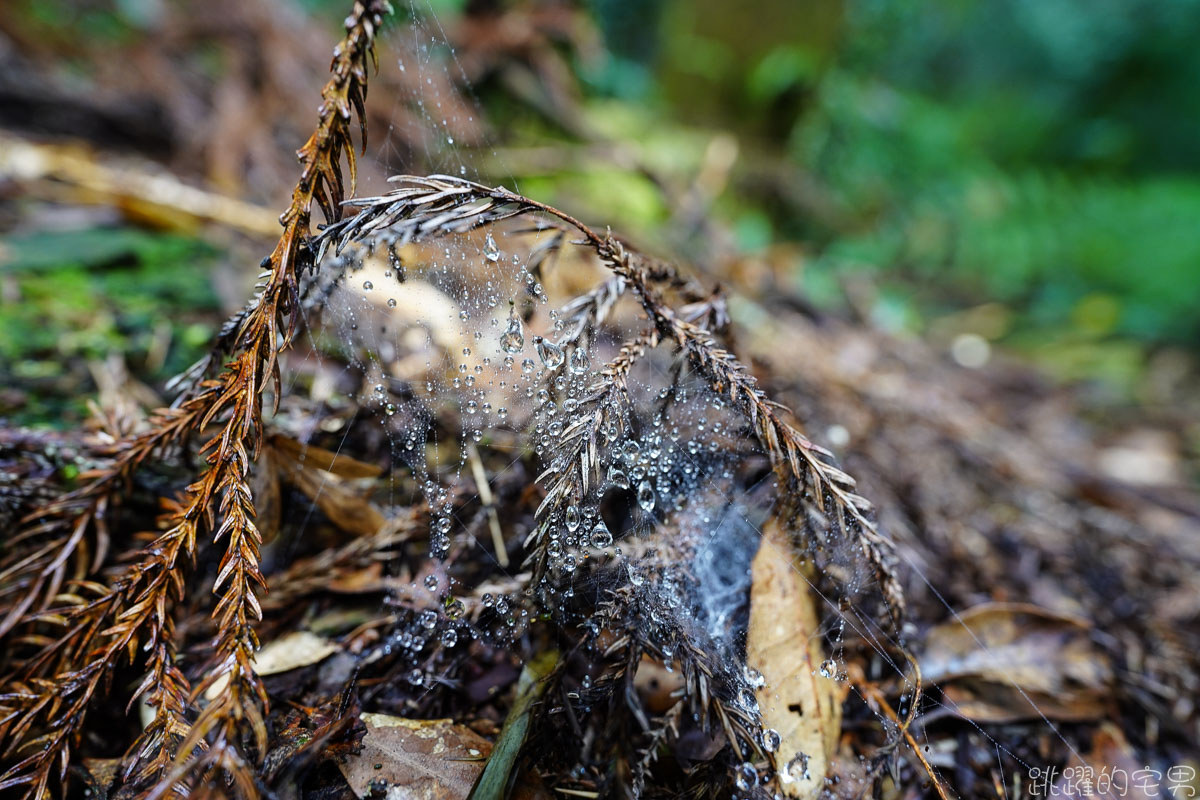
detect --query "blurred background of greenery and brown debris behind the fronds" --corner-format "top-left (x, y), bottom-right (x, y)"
top-left (0, 0), bottom-right (1200, 470)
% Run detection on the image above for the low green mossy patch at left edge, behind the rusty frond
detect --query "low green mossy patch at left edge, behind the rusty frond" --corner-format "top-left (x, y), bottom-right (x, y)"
top-left (0, 228), bottom-right (218, 426)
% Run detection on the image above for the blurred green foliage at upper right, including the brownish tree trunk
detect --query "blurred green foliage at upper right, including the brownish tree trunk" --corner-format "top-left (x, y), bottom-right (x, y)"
top-left (576, 0), bottom-right (1200, 384)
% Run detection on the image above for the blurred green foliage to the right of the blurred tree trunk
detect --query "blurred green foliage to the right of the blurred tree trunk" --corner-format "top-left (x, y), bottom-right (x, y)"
top-left (790, 0), bottom-right (1200, 345)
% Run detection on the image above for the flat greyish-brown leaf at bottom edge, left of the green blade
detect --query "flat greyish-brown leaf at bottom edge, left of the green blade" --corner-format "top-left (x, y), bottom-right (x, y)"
top-left (338, 714), bottom-right (492, 800)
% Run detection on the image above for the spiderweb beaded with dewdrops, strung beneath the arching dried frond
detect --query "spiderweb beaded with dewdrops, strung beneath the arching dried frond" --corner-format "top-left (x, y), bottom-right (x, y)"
top-left (276, 4), bottom-right (1099, 794)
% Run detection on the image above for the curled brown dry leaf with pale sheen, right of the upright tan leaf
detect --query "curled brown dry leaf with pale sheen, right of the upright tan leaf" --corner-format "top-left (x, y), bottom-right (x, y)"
top-left (919, 603), bottom-right (1112, 722)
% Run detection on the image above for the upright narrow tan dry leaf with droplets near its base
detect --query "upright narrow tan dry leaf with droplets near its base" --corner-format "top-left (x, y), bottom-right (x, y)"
top-left (746, 521), bottom-right (845, 798)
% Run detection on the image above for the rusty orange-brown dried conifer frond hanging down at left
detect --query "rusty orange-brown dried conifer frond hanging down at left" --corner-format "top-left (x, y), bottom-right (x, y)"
top-left (0, 0), bottom-right (391, 798)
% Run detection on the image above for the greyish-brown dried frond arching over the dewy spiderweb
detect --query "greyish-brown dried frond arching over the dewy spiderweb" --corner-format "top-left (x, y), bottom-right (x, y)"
top-left (318, 175), bottom-right (904, 616)
